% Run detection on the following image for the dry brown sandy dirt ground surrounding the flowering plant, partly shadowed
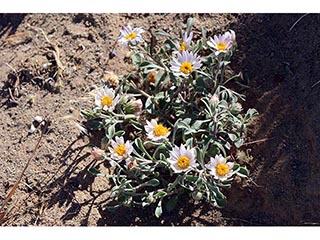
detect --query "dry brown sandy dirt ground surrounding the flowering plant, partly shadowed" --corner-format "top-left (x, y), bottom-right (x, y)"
top-left (0, 13), bottom-right (320, 226)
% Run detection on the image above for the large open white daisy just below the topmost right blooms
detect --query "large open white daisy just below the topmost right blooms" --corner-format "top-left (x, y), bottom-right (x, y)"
top-left (170, 51), bottom-right (202, 77)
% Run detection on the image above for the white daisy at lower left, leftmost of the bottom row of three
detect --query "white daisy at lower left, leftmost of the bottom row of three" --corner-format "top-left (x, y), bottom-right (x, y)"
top-left (108, 137), bottom-right (133, 160)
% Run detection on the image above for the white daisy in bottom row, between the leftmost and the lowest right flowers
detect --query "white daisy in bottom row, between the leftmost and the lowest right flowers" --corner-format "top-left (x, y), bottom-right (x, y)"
top-left (168, 144), bottom-right (199, 173)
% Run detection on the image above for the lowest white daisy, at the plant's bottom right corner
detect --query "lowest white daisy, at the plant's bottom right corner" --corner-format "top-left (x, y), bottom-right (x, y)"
top-left (205, 154), bottom-right (234, 181)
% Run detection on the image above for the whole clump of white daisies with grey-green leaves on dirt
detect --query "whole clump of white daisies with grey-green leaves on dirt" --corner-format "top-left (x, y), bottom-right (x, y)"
top-left (82, 19), bottom-right (257, 217)
